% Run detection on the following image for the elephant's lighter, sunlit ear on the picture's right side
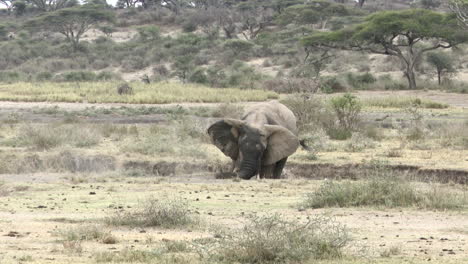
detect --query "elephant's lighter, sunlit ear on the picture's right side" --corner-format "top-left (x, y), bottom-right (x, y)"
top-left (263, 125), bottom-right (299, 165)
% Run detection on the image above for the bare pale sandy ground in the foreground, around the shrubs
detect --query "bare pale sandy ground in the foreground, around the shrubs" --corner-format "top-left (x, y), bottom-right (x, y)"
top-left (0, 174), bottom-right (468, 264)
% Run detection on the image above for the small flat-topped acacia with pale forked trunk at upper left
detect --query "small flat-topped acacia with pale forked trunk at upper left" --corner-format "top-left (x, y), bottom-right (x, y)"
top-left (26, 5), bottom-right (114, 51)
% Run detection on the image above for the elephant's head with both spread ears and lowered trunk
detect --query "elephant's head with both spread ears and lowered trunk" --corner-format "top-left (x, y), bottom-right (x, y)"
top-left (208, 119), bottom-right (299, 179)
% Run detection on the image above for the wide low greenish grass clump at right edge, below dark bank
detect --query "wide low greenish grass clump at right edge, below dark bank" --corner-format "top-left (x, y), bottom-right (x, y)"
top-left (299, 169), bottom-right (468, 210)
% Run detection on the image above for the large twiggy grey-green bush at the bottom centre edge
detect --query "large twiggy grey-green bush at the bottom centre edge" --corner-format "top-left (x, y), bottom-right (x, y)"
top-left (207, 214), bottom-right (349, 263)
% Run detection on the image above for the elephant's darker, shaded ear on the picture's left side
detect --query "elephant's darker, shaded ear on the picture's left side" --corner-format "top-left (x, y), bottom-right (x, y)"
top-left (208, 119), bottom-right (244, 160)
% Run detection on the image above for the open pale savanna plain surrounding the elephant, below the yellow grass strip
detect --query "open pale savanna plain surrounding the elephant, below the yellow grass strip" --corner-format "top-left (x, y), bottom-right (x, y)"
top-left (0, 84), bottom-right (468, 263)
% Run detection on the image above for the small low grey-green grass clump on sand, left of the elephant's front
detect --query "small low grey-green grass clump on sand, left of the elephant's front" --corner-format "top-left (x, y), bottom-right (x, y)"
top-left (106, 197), bottom-right (199, 228)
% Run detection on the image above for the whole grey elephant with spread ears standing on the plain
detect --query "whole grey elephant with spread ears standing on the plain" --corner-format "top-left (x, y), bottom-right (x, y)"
top-left (208, 101), bottom-right (299, 179)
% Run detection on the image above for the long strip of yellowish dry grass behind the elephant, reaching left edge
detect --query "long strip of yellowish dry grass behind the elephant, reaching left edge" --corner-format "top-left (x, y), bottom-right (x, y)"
top-left (0, 82), bottom-right (278, 104)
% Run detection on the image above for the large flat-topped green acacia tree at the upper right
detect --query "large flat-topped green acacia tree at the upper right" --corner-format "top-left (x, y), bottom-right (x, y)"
top-left (302, 9), bottom-right (468, 89)
